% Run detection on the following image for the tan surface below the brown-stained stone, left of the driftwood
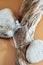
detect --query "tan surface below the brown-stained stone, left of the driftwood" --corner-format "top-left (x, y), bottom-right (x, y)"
top-left (0, 39), bottom-right (16, 65)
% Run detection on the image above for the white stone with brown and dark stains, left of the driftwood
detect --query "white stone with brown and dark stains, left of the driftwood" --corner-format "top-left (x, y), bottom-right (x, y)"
top-left (0, 8), bottom-right (16, 38)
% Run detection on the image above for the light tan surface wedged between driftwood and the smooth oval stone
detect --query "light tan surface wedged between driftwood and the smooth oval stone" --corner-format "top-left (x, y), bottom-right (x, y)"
top-left (34, 16), bottom-right (43, 40)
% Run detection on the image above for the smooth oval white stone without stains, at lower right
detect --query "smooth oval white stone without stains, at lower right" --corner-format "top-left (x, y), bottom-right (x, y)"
top-left (26, 40), bottom-right (43, 63)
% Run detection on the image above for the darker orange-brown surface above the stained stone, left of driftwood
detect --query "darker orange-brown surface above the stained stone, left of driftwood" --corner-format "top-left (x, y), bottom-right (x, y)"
top-left (0, 0), bottom-right (22, 18)
